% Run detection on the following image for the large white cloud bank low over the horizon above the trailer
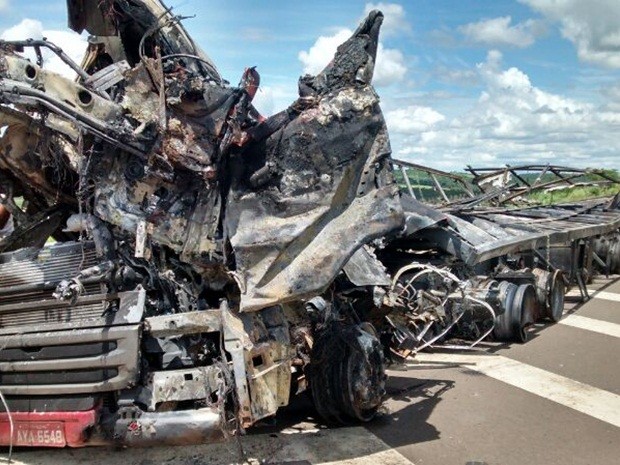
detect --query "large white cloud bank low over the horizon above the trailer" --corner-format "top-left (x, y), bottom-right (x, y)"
top-left (386, 51), bottom-right (620, 170)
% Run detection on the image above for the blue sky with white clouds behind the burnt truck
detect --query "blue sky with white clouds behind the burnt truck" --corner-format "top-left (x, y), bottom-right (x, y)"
top-left (0, 0), bottom-right (620, 170)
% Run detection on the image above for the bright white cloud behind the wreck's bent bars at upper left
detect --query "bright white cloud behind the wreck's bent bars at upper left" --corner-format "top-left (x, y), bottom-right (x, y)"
top-left (0, 17), bottom-right (87, 78)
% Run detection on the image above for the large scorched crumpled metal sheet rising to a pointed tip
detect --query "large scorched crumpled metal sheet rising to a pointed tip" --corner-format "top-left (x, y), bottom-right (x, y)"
top-left (226, 14), bottom-right (404, 311)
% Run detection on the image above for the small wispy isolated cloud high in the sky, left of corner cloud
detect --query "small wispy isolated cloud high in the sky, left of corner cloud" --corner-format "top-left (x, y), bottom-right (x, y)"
top-left (458, 16), bottom-right (545, 48)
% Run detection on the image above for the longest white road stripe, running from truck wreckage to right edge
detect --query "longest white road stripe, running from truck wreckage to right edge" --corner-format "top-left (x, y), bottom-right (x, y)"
top-left (412, 353), bottom-right (620, 428)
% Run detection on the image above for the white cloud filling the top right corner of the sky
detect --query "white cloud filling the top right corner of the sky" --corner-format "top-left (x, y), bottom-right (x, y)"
top-left (519, 0), bottom-right (620, 68)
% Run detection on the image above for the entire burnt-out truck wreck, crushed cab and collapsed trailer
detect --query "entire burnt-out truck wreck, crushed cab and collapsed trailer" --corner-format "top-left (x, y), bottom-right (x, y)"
top-left (0, 0), bottom-right (620, 447)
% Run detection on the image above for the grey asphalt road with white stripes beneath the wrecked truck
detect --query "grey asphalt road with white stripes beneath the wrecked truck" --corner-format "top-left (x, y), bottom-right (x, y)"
top-left (0, 279), bottom-right (620, 465)
